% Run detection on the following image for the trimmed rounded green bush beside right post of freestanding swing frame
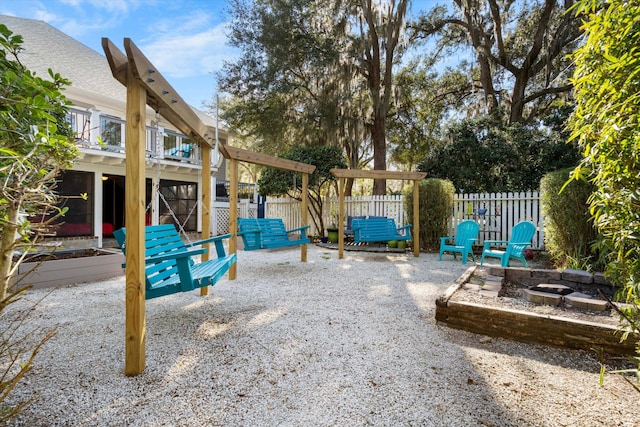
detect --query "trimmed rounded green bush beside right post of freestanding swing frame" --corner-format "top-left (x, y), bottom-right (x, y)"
top-left (404, 178), bottom-right (456, 249)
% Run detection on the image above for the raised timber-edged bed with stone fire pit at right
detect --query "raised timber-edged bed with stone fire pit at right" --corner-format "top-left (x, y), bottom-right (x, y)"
top-left (436, 266), bottom-right (639, 355)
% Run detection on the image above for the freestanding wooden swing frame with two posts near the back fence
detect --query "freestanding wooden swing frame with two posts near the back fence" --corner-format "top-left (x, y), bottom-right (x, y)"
top-left (331, 169), bottom-right (427, 259)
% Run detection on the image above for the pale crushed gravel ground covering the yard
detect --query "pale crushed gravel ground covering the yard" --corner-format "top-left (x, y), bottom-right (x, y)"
top-left (2, 246), bottom-right (640, 426)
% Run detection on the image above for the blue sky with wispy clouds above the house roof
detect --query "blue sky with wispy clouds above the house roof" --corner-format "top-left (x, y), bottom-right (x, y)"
top-left (0, 0), bottom-right (435, 108)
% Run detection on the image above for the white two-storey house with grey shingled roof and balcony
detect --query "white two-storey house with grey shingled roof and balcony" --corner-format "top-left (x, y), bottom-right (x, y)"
top-left (0, 15), bottom-right (230, 247)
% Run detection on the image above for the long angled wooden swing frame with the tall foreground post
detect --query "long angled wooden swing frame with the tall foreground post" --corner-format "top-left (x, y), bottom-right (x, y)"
top-left (102, 38), bottom-right (315, 375)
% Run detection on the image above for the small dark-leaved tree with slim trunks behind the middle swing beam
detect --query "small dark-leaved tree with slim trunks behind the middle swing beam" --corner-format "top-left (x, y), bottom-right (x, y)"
top-left (258, 146), bottom-right (347, 235)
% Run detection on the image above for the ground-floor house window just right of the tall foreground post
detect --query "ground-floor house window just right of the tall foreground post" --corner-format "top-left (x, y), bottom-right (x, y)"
top-left (159, 180), bottom-right (198, 231)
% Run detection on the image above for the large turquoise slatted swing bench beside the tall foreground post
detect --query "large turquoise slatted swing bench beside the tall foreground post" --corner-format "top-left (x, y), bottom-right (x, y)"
top-left (113, 224), bottom-right (237, 299)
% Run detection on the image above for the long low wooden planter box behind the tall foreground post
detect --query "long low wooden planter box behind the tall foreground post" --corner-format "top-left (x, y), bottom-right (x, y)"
top-left (12, 254), bottom-right (124, 289)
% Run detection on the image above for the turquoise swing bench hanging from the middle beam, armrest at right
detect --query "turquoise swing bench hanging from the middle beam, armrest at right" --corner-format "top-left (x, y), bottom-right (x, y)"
top-left (238, 218), bottom-right (311, 251)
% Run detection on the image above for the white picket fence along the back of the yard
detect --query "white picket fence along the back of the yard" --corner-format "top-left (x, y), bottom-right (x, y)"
top-left (214, 191), bottom-right (544, 249)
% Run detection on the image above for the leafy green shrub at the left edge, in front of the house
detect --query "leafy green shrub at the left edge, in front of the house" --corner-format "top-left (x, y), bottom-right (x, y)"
top-left (0, 25), bottom-right (77, 304)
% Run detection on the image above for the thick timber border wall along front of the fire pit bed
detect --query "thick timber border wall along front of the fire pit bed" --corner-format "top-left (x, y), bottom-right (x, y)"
top-left (436, 273), bottom-right (640, 355)
